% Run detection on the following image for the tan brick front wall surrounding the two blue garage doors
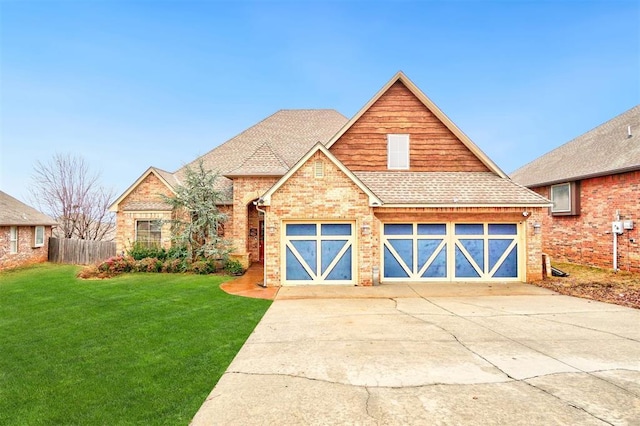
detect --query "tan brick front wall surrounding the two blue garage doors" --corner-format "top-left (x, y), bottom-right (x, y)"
top-left (265, 152), bottom-right (546, 286)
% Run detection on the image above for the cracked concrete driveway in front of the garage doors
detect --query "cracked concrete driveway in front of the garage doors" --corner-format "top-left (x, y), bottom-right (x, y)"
top-left (192, 284), bottom-right (640, 425)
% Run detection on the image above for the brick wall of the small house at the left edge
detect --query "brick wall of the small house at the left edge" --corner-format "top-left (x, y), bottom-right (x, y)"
top-left (0, 226), bottom-right (52, 270)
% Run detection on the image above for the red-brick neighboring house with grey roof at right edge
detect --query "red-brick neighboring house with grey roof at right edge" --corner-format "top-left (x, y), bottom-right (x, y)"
top-left (511, 105), bottom-right (640, 272)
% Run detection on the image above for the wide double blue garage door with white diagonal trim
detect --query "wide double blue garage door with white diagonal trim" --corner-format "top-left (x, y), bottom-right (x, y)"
top-left (382, 223), bottom-right (520, 281)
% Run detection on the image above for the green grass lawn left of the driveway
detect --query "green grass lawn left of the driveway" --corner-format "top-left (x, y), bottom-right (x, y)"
top-left (0, 264), bottom-right (271, 425)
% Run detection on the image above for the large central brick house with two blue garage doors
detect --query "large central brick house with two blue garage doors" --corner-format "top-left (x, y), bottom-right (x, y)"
top-left (111, 72), bottom-right (550, 286)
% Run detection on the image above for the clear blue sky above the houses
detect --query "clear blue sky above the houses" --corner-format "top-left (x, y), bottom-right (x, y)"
top-left (0, 0), bottom-right (640, 201)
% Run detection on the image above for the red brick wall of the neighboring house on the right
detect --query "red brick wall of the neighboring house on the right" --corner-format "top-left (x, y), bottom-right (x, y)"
top-left (533, 171), bottom-right (640, 272)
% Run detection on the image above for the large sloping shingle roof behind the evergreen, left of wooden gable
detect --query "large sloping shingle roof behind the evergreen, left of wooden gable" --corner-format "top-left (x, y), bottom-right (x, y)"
top-left (174, 109), bottom-right (347, 203)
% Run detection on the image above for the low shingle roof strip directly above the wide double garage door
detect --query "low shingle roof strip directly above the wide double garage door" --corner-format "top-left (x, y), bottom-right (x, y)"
top-left (354, 172), bottom-right (549, 205)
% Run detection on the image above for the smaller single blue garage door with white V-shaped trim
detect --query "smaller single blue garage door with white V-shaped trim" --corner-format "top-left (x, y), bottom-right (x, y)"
top-left (283, 223), bottom-right (355, 285)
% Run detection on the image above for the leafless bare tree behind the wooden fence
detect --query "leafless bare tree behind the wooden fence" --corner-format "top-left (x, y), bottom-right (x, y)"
top-left (29, 154), bottom-right (115, 240)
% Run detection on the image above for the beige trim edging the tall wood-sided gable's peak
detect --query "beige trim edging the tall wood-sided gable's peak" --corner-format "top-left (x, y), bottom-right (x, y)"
top-left (327, 71), bottom-right (508, 178)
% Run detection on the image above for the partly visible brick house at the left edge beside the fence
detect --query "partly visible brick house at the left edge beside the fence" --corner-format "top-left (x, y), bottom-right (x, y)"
top-left (0, 191), bottom-right (56, 270)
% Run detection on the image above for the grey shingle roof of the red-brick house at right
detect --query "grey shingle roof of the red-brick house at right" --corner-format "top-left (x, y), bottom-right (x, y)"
top-left (511, 105), bottom-right (640, 187)
